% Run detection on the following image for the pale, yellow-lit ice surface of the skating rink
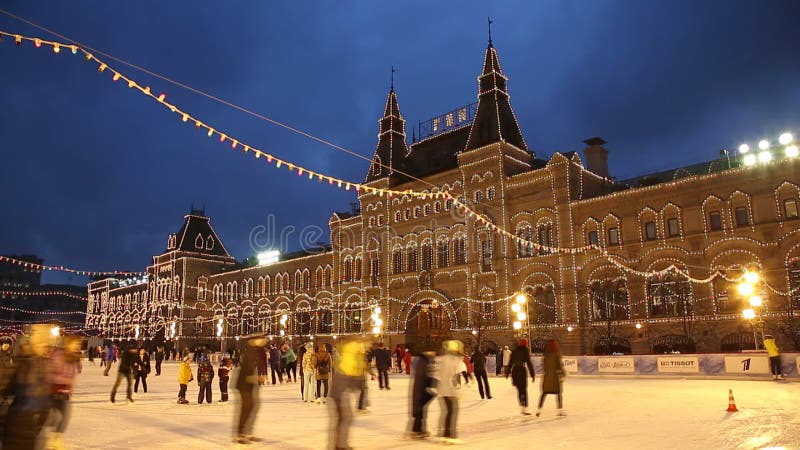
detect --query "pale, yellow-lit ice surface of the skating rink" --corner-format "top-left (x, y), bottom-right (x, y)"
top-left (66, 363), bottom-right (800, 450)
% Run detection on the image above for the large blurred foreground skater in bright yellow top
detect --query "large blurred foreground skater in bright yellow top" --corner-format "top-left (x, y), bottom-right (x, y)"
top-left (330, 339), bottom-right (367, 450)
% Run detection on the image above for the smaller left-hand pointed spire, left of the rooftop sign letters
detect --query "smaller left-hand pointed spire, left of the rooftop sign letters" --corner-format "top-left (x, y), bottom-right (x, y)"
top-left (366, 85), bottom-right (408, 182)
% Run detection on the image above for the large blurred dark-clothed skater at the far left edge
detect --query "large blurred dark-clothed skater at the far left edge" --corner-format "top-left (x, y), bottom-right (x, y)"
top-left (2, 325), bottom-right (52, 450)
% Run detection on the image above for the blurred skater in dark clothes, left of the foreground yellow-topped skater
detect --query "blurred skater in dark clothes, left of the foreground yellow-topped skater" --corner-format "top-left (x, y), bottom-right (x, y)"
top-left (234, 336), bottom-right (267, 444)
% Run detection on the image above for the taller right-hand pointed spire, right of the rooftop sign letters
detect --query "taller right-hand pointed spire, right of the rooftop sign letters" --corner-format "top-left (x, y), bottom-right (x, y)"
top-left (465, 32), bottom-right (528, 150)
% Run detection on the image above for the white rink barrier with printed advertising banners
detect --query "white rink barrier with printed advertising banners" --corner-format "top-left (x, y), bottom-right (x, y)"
top-left (486, 352), bottom-right (800, 378)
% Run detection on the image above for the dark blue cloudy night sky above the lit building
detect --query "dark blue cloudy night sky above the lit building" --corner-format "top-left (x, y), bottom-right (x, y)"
top-left (0, 0), bottom-right (800, 284)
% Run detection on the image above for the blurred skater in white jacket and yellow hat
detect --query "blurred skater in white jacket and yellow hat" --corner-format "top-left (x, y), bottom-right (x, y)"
top-left (435, 341), bottom-right (464, 444)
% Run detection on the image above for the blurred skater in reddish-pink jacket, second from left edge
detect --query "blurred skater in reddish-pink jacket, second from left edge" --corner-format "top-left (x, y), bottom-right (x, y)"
top-left (47, 335), bottom-right (83, 449)
